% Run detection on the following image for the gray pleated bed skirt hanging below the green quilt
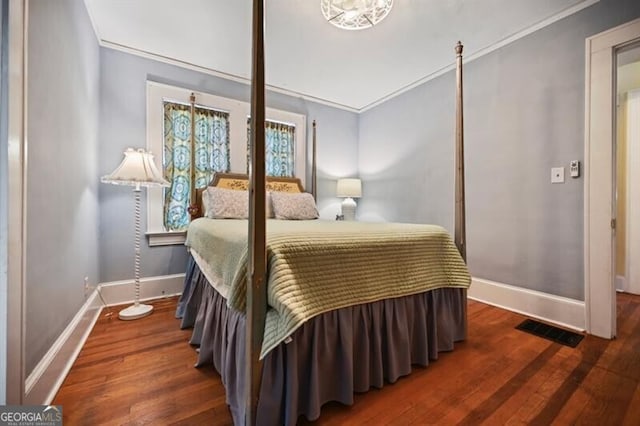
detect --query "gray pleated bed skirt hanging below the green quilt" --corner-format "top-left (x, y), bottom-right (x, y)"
top-left (176, 255), bottom-right (467, 425)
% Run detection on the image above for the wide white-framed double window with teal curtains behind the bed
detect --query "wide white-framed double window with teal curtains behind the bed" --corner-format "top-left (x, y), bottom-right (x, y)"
top-left (147, 81), bottom-right (306, 246)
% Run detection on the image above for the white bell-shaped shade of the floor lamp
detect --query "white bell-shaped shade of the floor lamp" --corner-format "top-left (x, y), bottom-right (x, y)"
top-left (100, 148), bottom-right (169, 187)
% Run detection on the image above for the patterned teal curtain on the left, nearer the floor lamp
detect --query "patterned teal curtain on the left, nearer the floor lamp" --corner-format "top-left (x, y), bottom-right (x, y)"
top-left (163, 102), bottom-right (229, 231)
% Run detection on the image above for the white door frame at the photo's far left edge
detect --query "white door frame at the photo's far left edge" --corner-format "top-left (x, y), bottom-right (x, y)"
top-left (6, 0), bottom-right (29, 405)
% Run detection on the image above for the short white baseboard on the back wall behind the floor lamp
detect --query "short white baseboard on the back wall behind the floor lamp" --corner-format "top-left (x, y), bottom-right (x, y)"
top-left (100, 274), bottom-right (184, 306)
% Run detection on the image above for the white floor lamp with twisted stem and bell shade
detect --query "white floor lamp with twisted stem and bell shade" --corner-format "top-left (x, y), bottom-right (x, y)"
top-left (101, 148), bottom-right (169, 320)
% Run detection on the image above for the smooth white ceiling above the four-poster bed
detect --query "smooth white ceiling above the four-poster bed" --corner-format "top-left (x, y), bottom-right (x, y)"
top-left (85, 0), bottom-right (597, 111)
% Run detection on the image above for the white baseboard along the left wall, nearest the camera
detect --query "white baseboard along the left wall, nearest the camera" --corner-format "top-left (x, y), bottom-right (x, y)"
top-left (24, 290), bottom-right (102, 405)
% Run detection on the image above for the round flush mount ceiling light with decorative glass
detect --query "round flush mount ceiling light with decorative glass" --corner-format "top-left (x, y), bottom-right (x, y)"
top-left (320, 0), bottom-right (393, 30)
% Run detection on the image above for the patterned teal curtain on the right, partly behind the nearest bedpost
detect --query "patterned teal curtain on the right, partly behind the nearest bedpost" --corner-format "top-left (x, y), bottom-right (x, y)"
top-left (247, 119), bottom-right (296, 177)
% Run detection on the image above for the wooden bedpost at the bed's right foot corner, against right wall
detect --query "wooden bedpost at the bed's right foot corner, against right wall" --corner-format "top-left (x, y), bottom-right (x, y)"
top-left (454, 41), bottom-right (467, 263)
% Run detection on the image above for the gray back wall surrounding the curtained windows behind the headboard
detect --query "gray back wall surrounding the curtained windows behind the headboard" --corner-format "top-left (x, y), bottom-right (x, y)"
top-left (96, 48), bottom-right (358, 282)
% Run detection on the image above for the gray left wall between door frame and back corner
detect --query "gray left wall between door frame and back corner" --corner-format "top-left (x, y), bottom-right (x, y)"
top-left (25, 0), bottom-right (99, 375)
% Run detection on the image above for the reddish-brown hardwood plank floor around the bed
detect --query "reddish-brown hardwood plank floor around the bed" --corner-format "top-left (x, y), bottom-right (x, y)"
top-left (53, 294), bottom-right (640, 425)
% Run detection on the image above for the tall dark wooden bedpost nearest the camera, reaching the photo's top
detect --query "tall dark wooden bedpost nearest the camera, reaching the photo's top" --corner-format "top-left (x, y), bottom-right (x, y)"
top-left (245, 0), bottom-right (267, 425)
